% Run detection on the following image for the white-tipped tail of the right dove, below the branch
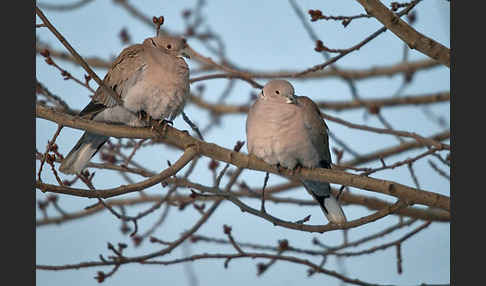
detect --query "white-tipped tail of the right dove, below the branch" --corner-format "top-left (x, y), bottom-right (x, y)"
top-left (302, 180), bottom-right (346, 224)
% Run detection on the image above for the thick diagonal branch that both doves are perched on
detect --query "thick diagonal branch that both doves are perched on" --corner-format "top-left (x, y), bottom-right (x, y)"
top-left (36, 104), bottom-right (450, 211)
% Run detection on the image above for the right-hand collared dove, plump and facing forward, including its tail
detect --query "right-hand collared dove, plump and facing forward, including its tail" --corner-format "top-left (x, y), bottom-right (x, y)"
top-left (246, 80), bottom-right (346, 224)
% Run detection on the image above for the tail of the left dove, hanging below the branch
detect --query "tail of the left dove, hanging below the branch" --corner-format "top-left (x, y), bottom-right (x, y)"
top-left (59, 132), bottom-right (109, 174)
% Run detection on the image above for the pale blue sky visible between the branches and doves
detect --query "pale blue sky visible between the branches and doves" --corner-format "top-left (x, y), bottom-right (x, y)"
top-left (36, 1), bottom-right (450, 286)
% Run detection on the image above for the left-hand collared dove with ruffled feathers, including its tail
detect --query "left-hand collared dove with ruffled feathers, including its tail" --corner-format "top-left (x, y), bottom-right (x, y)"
top-left (59, 36), bottom-right (189, 174)
